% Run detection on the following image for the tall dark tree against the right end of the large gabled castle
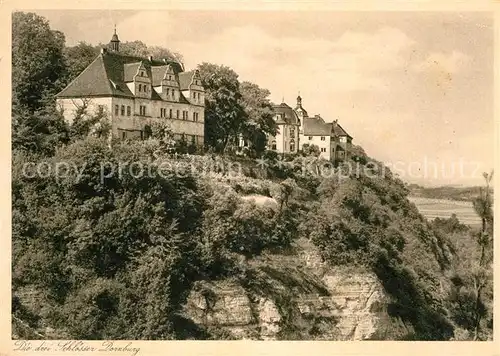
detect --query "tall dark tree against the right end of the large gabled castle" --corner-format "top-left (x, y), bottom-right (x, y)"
top-left (198, 63), bottom-right (246, 152)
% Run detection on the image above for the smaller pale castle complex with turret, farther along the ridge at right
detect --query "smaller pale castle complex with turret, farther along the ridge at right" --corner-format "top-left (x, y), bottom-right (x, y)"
top-left (268, 95), bottom-right (352, 161)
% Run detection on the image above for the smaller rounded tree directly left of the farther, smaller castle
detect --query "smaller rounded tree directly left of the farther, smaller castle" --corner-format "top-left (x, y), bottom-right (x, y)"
top-left (240, 82), bottom-right (277, 156)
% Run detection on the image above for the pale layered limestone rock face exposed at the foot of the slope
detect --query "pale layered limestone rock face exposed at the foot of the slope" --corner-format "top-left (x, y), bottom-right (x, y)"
top-left (184, 241), bottom-right (388, 340)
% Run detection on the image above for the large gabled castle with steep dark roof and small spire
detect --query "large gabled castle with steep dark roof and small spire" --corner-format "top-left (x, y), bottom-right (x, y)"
top-left (56, 30), bottom-right (205, 146)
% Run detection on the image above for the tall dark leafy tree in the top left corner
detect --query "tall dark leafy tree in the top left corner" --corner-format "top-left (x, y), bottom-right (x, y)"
top-left (12, 12), bottom-right (66, 112)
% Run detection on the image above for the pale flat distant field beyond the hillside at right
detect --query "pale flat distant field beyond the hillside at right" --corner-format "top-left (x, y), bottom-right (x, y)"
top-left (409, 197), bottom-right (481, 225)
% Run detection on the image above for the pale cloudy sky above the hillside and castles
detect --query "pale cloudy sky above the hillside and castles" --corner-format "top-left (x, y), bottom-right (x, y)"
top-left (36, 10), bottom-right (494, 185)
